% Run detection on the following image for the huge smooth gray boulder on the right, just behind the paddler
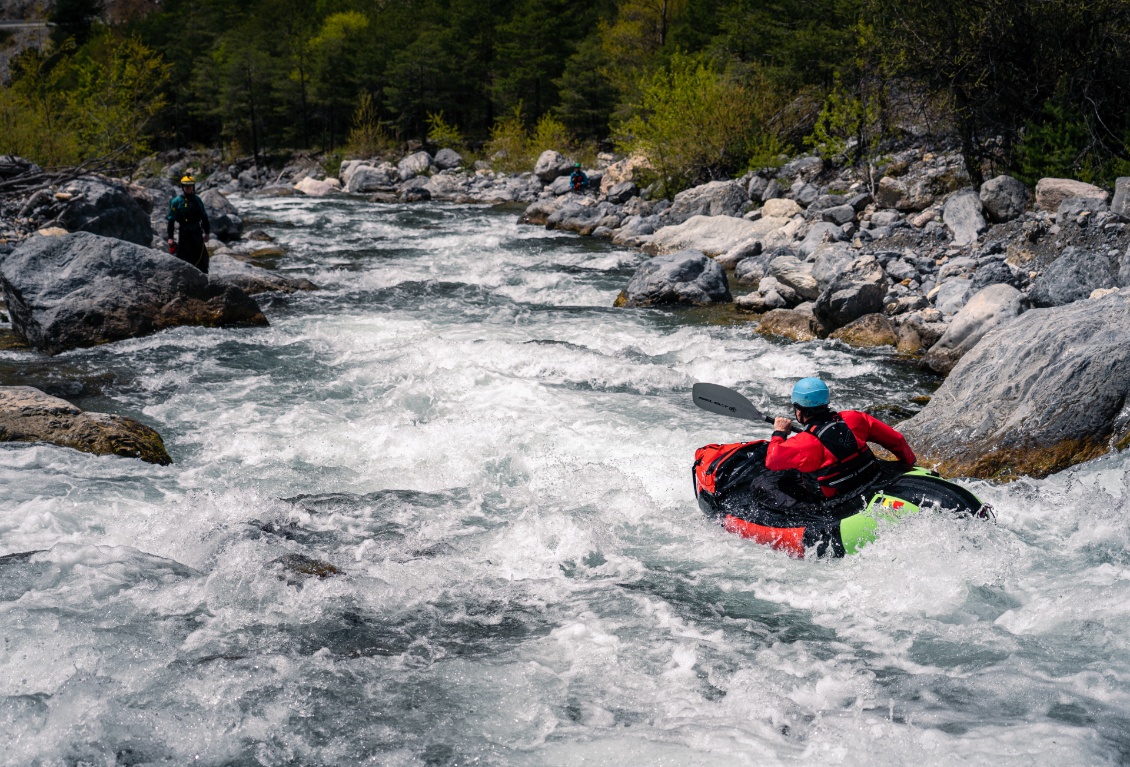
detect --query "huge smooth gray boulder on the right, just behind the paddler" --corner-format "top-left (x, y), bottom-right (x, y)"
top-left (899, 293), bottom-right (1130, 477)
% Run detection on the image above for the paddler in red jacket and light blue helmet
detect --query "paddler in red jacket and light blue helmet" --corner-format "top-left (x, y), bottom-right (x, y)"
top-left (765, 378), bottom-right (916, 498)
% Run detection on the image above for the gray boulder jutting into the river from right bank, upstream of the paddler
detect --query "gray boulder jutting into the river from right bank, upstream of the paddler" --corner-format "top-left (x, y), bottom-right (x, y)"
top-left (616, 251), bottom-right (732, 306)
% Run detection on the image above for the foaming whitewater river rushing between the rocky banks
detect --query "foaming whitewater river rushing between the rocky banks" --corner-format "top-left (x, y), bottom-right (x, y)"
top-left (0, 199), bottom-right (1130, 767)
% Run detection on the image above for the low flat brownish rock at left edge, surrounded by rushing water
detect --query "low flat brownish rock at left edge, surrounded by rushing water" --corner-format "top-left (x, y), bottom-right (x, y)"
top-left (0, 386), bottom-right (173, 467)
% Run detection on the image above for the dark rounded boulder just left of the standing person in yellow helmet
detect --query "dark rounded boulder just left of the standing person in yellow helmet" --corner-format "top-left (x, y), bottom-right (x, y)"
top-left (55, 176), bottom-right (153, 245)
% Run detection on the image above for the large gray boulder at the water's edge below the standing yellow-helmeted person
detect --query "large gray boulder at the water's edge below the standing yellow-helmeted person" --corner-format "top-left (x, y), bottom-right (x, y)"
top-left (0, 233), bottom-right (267, 354)
